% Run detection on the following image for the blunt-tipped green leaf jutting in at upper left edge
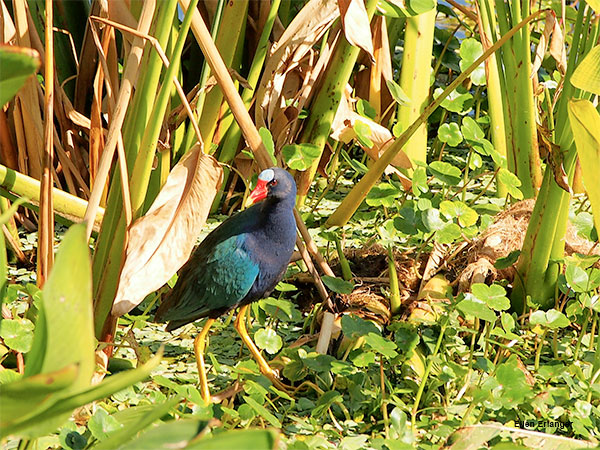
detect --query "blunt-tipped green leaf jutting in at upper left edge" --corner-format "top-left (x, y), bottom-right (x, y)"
top-left (0, 45), bottom-right (41, 108)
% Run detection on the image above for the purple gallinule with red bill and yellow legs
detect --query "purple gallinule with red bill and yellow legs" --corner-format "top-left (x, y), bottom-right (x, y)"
top-left (155, 167), bottom-right (296, 401)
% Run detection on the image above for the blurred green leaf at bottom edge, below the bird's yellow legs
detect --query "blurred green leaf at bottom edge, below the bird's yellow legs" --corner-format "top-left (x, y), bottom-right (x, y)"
top-left (185, 429), bottom-right (279, 450)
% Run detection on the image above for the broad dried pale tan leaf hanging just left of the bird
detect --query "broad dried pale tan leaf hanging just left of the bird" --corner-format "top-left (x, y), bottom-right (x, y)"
top-left (112, 145), bottom-right (223, 316)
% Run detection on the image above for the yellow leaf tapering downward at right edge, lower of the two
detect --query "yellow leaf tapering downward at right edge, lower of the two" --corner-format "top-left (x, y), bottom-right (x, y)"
top-left (569, 100), bottom-right (600, 230)
